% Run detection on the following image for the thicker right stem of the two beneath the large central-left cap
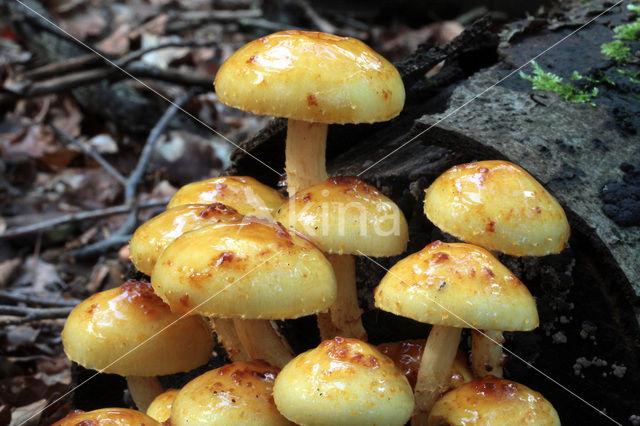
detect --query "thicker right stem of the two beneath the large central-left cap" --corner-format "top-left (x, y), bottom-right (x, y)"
top-left (233, 319), bottom-right (293, 368)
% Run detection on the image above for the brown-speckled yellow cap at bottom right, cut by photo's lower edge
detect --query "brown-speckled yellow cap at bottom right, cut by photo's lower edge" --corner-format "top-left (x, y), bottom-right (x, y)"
top-left (427, 376), bottom-right (560, 426)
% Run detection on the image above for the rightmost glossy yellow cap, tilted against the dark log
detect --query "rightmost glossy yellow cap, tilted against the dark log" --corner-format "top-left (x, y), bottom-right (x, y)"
top-left (424, 161), bottom-right (571, 256)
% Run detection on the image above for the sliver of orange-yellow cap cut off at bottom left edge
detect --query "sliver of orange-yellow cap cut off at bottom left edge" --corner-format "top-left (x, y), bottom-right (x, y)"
top-left (53, 408), bottom-right (161, 426)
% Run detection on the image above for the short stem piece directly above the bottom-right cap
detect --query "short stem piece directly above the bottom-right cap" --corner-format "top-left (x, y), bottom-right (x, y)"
top-left (471, 330), bottom-right (504, 378)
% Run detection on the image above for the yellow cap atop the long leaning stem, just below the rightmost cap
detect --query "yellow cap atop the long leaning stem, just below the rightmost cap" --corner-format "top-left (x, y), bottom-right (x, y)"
top-left (374, 241), bottom-right (538, 331)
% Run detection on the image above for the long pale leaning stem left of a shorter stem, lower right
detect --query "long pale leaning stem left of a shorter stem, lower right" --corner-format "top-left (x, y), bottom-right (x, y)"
top-left (411, 325), bottom-right (462, 426)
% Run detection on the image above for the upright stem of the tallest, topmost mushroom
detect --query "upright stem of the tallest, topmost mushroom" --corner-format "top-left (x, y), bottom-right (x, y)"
top-left (285, 119), bottom-right (329, 197)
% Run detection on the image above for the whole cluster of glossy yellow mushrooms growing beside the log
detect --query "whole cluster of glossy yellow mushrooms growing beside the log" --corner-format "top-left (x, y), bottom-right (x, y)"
top-left (56, 31), bottom-right (569, 426)
